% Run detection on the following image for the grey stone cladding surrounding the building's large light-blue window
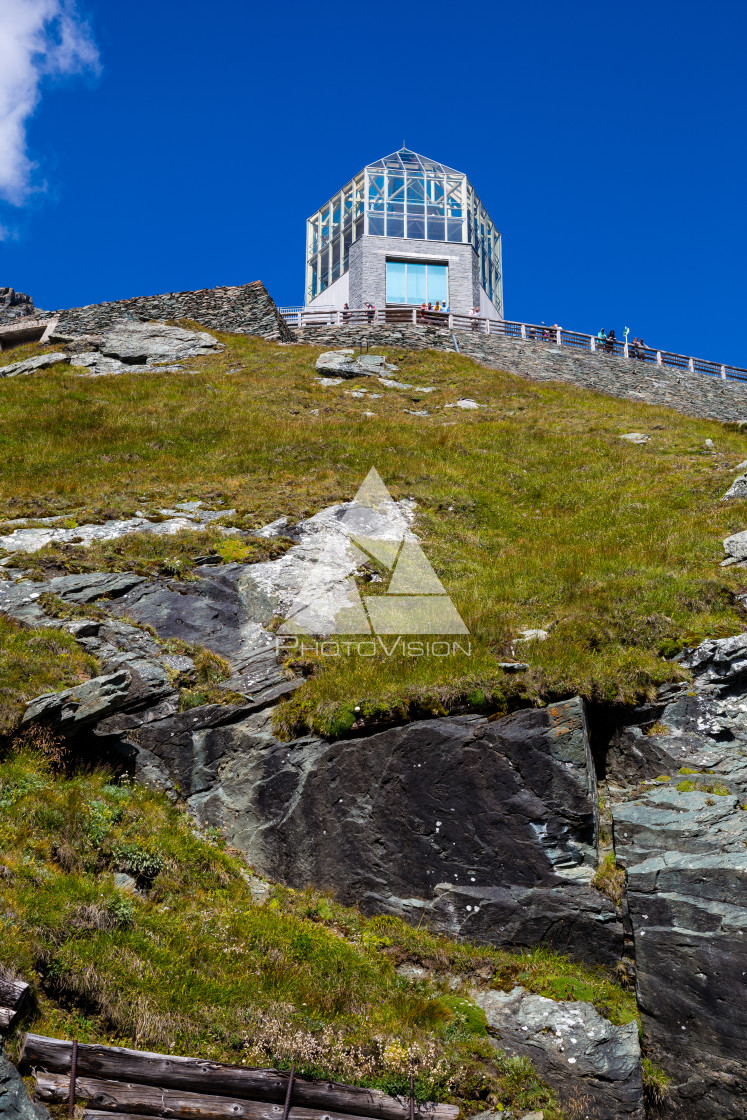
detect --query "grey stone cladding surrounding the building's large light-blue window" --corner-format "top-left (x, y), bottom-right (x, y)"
top-left (348, 235), bottom-right (479, 315)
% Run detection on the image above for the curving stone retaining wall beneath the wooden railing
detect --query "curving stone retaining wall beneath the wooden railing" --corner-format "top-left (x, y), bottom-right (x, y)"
top-left (295, 324), bottom-right (747, 422)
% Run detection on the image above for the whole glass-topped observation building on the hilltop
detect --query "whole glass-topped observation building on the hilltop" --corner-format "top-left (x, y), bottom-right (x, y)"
top-left (306, 148), bottom-right (503, 318)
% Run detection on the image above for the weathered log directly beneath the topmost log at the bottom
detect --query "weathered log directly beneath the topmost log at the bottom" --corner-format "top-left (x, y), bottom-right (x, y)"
top-left (36, 1073), bottom-right (418, 1120)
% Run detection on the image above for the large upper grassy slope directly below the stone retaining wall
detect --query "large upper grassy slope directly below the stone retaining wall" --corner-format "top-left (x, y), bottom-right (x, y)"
top-left (0, 335), bottom-right (747, 735)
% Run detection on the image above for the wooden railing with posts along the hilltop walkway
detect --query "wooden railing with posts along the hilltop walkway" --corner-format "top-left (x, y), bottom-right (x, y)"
top-left (279, 307), bottom-right (747, 381)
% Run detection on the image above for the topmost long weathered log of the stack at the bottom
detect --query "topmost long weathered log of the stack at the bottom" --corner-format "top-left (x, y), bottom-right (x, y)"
top-left (19, 1033), bottom-right (459, 1120)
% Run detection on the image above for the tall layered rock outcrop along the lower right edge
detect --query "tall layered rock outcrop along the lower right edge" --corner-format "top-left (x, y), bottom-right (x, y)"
top-left (607, 635), bottom-right (747, 1120)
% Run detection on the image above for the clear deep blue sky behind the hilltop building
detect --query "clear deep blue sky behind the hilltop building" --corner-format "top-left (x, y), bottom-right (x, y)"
top-left (0, 0), bottom-right (747, 366)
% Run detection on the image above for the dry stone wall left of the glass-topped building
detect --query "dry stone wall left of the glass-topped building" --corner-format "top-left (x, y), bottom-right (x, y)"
top-left (54, 280), bottom-right (293, 342)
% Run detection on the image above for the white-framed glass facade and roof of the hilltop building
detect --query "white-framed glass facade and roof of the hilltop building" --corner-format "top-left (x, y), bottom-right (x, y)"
top-left (306, 148), bottom-right (503, 315)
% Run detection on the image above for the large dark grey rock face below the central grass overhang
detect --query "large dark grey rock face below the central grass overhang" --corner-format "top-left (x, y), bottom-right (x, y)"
top-left (133, 700), bottom-right (623, 964)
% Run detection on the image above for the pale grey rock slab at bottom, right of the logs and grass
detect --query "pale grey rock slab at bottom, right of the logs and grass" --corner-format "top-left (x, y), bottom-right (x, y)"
top-left (473, 987), bottom-right (645, 1120)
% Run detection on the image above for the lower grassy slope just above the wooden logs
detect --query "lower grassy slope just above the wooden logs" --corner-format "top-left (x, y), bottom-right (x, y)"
top-left (0, 750), bottom-right (635, 1120)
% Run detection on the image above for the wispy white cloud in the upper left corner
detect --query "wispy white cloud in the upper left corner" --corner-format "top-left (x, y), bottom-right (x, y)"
top-left (0, 0), bottom-right (99, 206)
